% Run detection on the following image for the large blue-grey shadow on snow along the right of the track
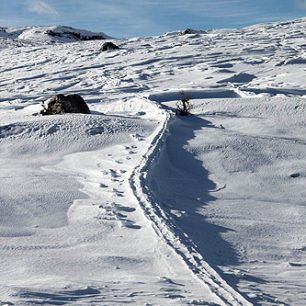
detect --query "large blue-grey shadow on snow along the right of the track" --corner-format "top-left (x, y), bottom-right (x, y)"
top-left (149, 116), bottom-right (261, 302)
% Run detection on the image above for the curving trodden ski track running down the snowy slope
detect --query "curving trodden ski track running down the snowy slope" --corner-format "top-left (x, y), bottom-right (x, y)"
top-left (129, 104), bottom-right (252, 306)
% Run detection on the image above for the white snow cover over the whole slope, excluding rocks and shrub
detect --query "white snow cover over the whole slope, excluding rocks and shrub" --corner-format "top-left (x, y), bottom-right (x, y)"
top-left (0, 19), bottom-right (306, 305)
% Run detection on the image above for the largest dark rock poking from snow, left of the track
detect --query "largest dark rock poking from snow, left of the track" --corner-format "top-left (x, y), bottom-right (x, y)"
top-left (40, 95), bottom-right (90, 115)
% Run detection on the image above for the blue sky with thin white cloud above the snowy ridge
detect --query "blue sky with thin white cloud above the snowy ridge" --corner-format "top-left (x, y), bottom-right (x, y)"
top-left (0, 0), bottom-right (306, 37)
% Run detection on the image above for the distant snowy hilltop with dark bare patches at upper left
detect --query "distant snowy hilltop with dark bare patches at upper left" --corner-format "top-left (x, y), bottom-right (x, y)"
top-left (0, 26), bottom-right (111, 43)
